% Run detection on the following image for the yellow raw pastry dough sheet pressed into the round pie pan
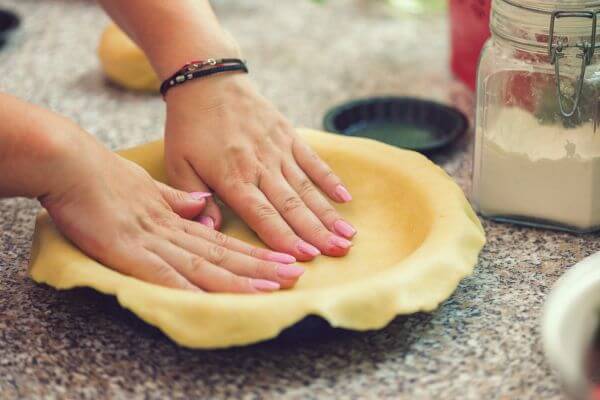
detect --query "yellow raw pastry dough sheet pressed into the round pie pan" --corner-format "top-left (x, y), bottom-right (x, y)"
top-left (29, 131), bottom-right (485, 348)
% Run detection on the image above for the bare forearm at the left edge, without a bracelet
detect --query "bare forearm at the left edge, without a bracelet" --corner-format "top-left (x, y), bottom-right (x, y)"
top-left (0, 94), bottom-right (83, 198)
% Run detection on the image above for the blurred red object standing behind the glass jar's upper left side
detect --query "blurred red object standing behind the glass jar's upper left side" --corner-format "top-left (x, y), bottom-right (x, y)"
top-left (450, 0), bottom-right (492, 90)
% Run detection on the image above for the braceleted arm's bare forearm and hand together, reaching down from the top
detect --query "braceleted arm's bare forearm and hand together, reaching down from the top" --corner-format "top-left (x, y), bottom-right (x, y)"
top-left (95, 0), bottom-right (356, 261)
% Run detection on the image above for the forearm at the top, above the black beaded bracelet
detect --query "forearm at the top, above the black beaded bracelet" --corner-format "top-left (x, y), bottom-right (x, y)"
top-left (99, 0), bottom-right (238, 79)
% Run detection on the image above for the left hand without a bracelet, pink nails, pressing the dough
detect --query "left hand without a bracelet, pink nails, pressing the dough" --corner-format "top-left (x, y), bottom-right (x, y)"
top-left (40, 130), bottom-right (303, 293)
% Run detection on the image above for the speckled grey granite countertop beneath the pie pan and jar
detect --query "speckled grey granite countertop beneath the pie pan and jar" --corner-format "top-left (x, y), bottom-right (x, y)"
top-left (0, 0), bottom-right (600, 399)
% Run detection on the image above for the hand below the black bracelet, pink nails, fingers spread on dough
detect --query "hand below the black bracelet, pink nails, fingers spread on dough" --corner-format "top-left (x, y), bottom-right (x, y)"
top-left (165, 74), bottom-right (356, 261)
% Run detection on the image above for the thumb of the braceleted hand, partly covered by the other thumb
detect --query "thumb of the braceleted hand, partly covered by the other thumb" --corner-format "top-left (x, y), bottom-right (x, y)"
top-left (167, 159), bottom-right (223, 229)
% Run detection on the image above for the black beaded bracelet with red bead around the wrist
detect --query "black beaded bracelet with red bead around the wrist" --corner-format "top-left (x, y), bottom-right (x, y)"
top-left (160, 58), bottom-right (248, 97)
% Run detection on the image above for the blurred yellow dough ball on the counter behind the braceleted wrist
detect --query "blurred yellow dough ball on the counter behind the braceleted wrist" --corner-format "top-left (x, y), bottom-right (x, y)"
top-left (98, 24), bottom-right (160, 92)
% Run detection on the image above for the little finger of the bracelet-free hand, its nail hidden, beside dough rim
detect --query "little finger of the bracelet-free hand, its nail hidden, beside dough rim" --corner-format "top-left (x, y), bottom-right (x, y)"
top-left (119, 249), bottom-right (200, 291)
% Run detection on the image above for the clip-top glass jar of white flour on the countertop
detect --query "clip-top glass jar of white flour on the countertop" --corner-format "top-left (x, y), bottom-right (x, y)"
top-left (472, 0), bottom-right (600, 232)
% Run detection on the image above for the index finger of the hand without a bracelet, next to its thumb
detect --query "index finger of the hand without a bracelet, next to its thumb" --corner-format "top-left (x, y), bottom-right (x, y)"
top-left (181, 220), bottom-right (296, 264)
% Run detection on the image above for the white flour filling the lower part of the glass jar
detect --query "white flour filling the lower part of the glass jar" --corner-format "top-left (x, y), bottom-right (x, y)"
top-left (473, 107), bottom-right (600, 229)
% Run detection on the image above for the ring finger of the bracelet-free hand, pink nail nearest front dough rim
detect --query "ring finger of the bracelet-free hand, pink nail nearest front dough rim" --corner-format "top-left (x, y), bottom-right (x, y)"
top-left (148, 240), bottom-right (280, 293)
